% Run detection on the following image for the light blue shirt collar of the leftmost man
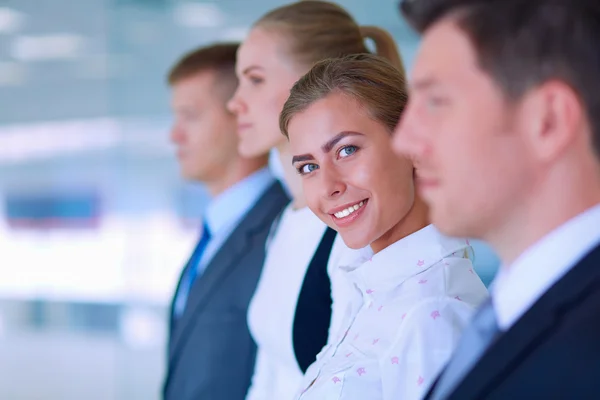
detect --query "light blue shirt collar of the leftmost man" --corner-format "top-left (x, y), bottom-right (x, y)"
top-left (205, 168), bottom-right (275, 235)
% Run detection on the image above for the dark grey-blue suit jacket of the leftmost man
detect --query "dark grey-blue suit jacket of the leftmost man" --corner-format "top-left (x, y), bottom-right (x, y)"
top-left (163, 183), bottom-right (289, 400)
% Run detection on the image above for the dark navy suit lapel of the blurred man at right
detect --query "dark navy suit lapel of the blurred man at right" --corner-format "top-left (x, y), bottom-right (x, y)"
top-left (449, 246), bottom-right (600, 400)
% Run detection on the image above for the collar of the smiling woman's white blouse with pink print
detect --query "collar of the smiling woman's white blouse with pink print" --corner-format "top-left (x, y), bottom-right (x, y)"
top-left (340, 225), bottom-right (470, 294)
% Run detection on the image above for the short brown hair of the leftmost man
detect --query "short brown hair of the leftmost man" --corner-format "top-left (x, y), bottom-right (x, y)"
top-left (167, 43), bottom-right (239, 99)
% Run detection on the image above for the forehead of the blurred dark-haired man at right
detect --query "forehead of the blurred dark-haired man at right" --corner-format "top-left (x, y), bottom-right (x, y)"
top-left (412, 19), bottom-right (481, 86)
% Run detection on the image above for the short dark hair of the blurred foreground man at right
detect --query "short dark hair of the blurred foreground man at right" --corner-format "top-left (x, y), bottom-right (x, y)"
top-left (400, 0), bottom-right (600, 157)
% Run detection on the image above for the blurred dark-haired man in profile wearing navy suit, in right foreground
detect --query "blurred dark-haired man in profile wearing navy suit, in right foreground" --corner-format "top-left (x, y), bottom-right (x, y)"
top-left (394, 0), bottom-right (600, 400)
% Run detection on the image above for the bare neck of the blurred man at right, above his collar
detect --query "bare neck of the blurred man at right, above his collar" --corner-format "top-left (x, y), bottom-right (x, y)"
top-left (482, 159), bottom-right (600, 266)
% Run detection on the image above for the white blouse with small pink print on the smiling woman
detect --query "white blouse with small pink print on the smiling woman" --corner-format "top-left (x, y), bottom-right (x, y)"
top-left (297, 225), bottom-right (488, 400)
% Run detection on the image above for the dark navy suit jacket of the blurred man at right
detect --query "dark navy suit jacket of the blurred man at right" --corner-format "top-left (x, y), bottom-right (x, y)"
top-left (426, 241), bottom-right (600, 400)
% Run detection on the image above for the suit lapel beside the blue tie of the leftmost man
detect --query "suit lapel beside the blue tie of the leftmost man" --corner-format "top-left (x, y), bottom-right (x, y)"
top-left (170, 183), bottom-right (286, 361)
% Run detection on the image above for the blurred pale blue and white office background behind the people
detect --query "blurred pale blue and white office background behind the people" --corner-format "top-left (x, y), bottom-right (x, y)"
top-left (0, 0), bottom-right (497, 400)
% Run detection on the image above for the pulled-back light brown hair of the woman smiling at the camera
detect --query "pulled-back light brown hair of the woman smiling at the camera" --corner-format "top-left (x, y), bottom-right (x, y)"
top-left (279, 54), bottom-right (408, 138)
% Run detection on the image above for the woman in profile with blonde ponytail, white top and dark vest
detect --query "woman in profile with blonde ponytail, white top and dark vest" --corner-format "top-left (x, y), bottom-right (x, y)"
top-left (229, 1), bottom-right (402, 400)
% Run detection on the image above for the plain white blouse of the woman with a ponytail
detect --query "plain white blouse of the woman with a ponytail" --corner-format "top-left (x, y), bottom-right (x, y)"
top-left (246, 205), bottom-right (345, 400)
